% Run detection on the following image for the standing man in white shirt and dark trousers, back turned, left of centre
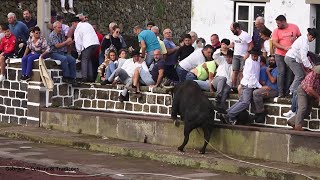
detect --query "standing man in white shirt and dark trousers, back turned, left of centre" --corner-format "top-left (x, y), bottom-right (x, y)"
top-left (74, 18), bottom-right (100, 82)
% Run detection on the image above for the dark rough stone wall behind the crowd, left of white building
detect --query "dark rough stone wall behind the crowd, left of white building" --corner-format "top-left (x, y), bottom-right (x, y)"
top-left (0, 0), bottom-right (191, 38)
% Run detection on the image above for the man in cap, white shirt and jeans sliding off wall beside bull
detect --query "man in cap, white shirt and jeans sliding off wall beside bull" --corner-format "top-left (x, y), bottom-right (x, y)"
top-left (221, 49), bottom-right (262, 125)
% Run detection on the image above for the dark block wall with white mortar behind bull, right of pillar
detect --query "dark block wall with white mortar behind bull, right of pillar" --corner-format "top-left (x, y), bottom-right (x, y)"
top-left (49, 67), bottom-right (320, 131)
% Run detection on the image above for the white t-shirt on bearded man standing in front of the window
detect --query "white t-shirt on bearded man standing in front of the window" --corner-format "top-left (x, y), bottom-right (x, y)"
top-left (232, 31), bottom-right (252, 56)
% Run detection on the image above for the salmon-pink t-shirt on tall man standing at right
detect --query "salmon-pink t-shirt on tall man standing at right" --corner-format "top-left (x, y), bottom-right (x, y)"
top-left (272, 24), bottom-right (301, 56)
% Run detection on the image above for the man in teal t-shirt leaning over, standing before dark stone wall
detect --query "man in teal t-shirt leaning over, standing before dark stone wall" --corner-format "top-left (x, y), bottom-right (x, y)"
top-left (133, 26), bottom-right (160, 67)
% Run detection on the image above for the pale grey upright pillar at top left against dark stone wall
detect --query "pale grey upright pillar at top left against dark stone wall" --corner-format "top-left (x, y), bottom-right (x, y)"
top-left (37, 0), bottom-right (51, 39)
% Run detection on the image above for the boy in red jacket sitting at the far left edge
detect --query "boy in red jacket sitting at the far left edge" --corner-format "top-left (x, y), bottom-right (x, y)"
top-left (0, 24), bottom-right (16, 82)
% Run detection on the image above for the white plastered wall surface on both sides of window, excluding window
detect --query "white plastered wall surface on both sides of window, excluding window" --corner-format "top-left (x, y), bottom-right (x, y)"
top-left (191, 0), bottom-right (315, 50)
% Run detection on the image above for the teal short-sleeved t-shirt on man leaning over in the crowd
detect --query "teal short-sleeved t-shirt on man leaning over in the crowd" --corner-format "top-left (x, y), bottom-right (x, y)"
top-left (138, 30), bottom-right (160, 52)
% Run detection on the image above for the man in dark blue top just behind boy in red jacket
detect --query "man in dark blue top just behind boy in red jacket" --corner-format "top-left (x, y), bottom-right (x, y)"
top-left (8, 12), bottom-right (29, 57)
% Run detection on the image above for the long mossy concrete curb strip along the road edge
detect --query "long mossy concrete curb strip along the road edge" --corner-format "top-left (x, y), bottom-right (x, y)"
top-left (0, 128), bottom-right (319, 180)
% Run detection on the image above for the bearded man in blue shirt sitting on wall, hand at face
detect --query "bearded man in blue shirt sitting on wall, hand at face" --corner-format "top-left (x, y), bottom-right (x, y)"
top-left (253, 55), bottom-right (278, 123)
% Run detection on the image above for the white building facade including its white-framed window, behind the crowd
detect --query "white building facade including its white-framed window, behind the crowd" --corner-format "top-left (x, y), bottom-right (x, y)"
top-left (191, 0), bottom-right (320, 52)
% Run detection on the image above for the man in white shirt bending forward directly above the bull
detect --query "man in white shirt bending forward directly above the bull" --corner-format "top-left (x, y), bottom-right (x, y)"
top-left (176, 45), bottom-right (213, 82)
